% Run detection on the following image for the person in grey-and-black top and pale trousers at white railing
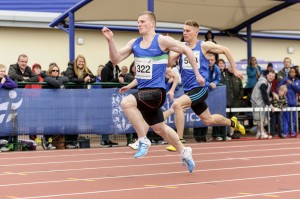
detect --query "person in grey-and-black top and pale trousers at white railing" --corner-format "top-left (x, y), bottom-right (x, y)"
top-left (251, 71), bottom-right (275, 139)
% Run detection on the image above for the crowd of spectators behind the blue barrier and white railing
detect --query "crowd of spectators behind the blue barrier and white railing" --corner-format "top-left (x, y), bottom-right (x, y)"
top-left (0, 31), bottom-right (300, 151)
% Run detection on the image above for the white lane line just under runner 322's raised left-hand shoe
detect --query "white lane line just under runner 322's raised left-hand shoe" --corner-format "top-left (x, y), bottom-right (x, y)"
top-left (0, 147), bottom-right (300, 168)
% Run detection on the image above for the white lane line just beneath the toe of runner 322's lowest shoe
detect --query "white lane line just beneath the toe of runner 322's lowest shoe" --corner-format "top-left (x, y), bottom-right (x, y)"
top-left (0, 162), bottom-right (300, 187)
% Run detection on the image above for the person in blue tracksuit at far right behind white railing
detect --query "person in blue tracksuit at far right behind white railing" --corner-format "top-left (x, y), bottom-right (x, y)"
top-left (278, 67), bottom-right (300, 137)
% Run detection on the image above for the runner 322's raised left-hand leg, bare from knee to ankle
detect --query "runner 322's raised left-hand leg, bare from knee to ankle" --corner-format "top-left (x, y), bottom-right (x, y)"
top-left (121, 95), bottom-right (149, 138)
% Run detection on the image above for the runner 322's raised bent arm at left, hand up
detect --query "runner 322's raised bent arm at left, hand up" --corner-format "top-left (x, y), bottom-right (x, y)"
top-left (102, 27), bottom-right (135, 64)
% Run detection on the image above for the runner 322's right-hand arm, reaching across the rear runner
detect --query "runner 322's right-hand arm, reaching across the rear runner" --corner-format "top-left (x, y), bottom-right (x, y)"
top-left (158, 36), bottom-right (204, 85)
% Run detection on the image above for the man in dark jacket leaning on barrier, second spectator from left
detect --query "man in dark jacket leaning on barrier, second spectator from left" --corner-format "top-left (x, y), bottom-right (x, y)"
top-left (8, 54), bottom-right (39, 86)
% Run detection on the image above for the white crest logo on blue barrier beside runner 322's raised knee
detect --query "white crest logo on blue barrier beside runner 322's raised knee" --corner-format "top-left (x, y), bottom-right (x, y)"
top-left (112, 94), bottom-right (131, 132)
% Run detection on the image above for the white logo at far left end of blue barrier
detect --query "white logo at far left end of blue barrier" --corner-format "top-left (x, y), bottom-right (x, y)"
top-left (0, 90), bottom-right (23, 124)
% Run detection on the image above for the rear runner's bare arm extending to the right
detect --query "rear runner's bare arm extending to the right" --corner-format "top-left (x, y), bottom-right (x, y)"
top-left (201, 41), bottom-right (243, 79)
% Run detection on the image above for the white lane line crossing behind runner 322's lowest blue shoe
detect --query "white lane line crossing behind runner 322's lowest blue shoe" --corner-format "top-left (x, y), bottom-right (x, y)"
top-left (0, 153), bottom-right (300, 176)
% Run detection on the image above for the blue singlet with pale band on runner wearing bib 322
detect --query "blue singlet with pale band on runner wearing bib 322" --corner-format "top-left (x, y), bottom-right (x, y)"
top-left (132, 34), bottom-right (169, 89)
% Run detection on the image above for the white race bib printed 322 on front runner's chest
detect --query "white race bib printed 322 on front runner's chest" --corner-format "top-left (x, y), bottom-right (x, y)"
top-left (134, 58), bottom-right (153, 79)
